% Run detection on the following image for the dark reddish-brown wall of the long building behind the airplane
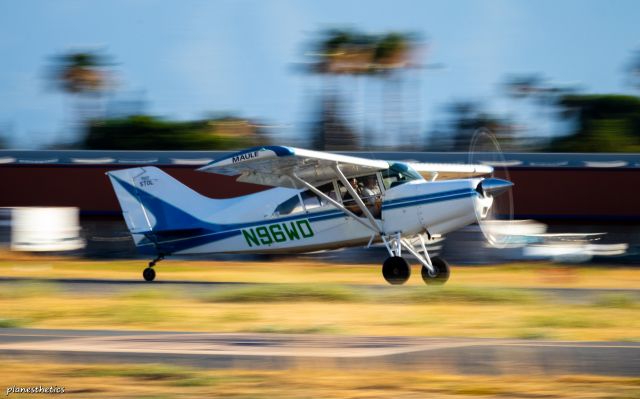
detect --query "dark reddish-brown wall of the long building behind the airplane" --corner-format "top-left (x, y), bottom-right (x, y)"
top-left (0, 164), bottom-right (640, 221)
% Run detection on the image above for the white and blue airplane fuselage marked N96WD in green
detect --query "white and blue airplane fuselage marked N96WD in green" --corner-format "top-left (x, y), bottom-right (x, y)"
top-left (133, 179), bottom-right (490, 255)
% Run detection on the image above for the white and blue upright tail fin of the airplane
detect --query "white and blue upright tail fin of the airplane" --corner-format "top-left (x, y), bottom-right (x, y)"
top-left (107, 166), bottom-right (214, 237)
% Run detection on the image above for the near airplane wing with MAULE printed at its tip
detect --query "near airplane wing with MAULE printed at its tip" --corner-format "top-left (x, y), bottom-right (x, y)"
top-left (198, 146), bottom-right (389, 188)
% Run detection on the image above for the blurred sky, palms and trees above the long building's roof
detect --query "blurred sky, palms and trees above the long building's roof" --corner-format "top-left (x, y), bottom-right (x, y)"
top-left (0, 0), bottom-right (640, 152)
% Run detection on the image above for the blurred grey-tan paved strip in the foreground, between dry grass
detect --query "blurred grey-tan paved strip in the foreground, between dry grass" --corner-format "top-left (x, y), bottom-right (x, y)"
top-left (0, 329), bottom-right (640, 376)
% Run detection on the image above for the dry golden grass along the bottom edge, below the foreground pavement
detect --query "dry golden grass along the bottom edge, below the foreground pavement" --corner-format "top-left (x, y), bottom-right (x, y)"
top-left (0, 358), bottom-right (640, 399)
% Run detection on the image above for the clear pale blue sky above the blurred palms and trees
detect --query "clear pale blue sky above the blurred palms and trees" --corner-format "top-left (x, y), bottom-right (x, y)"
top-left (0, 0), bottom-right (640, 149)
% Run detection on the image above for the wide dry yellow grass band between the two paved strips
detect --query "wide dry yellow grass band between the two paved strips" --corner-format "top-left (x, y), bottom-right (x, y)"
top-left (0, 283), bottom-right (640, 341)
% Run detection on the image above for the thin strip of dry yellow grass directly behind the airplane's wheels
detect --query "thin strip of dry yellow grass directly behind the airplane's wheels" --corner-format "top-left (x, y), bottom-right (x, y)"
top-left (0, 253), bottom-right (640, 289)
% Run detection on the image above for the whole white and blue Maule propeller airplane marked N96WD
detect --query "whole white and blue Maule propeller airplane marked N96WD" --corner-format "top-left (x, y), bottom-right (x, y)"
top-left (107, 146), bottom-right (513, 285)
